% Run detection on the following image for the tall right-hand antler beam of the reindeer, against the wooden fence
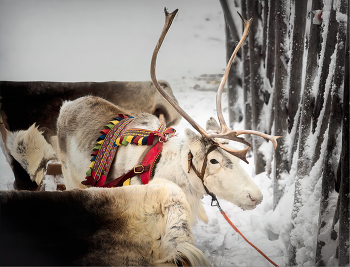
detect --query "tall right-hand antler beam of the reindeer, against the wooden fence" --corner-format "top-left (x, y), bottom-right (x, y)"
top-left (216, 12), bottom-right (253, 136)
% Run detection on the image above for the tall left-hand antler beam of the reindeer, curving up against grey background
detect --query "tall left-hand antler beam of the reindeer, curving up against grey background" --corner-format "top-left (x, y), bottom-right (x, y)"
top-left (151, 8), bottom-right (208, 138)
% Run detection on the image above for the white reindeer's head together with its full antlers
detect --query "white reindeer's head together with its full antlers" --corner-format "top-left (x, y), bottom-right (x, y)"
top-left (151, 9), bottom-right (279, 209)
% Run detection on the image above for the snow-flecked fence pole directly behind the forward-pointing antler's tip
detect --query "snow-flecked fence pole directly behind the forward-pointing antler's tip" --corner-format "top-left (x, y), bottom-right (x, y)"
top-left (273, 0), bottom-right (288, 209)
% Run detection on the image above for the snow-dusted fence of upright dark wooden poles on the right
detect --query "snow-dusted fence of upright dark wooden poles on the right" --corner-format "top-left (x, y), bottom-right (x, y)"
top-left (220, 0), bottom-right (350, 266)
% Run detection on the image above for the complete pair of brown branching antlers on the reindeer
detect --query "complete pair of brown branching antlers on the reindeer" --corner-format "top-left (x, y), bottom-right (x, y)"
top-left (151, 8), bottom-right (279, 163)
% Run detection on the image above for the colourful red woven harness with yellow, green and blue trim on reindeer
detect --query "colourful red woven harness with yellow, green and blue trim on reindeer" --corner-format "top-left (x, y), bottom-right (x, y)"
top-left (82, 114), bottom-right (175, 187)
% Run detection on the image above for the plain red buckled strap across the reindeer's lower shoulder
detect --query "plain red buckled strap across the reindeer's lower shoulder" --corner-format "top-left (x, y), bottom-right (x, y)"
top-left (102, 142), bottom-right (163, 188)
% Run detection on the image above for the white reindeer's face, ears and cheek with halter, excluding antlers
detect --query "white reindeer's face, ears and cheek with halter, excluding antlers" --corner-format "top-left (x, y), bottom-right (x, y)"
top-left (183, 118), bottom-right (262, 210)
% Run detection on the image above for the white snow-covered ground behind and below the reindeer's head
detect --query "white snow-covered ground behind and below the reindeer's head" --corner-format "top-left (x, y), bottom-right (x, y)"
top-left (0, 0), bottom-right (294, 266)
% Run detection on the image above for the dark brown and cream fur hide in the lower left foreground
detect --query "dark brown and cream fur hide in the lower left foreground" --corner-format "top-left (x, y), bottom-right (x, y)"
top-left (0, 180), bottom-right (207, 266)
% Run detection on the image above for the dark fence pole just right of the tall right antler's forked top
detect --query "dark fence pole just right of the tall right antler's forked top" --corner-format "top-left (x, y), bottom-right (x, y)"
top-left (247, 0), bottom-right (265, 174)
